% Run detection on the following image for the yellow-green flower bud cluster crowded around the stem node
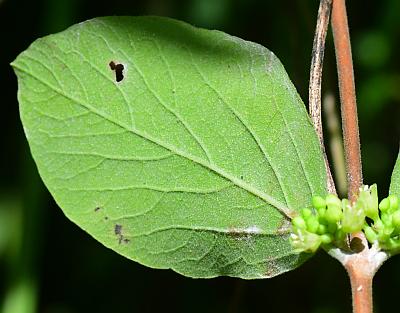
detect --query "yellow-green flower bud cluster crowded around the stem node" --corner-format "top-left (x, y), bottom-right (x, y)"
top-left (291, 185), bottom-right (400, 252)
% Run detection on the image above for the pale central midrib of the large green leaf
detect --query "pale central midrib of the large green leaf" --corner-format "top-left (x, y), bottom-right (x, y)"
top-left (11, 60), bottom-right (295, 219)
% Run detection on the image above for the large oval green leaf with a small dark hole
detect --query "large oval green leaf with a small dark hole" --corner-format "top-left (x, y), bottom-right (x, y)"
top-left (12, 17), bottom-right (326, 279)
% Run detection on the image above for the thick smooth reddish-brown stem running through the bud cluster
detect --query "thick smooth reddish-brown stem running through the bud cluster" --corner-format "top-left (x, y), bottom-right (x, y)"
top-left (332, 0), bottom-right (376, 313)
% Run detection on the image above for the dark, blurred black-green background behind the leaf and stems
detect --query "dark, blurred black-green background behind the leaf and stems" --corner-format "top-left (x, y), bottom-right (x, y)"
top-left (0, 0), bottom-right (400, 313)
